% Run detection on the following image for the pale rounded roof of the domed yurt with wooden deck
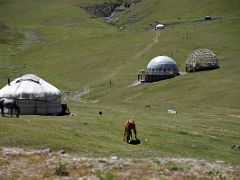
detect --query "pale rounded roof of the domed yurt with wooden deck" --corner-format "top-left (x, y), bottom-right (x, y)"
top-left (147, 56), bottom-right (177, 69)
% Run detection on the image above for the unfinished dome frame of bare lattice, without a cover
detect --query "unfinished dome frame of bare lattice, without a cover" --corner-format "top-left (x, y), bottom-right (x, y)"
top-left (186, 49), bottom-right (219, 72)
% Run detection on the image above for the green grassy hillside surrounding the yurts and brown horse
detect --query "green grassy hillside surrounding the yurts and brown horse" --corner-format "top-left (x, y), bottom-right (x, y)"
top-left (0, 0), bottom-right (240, 164)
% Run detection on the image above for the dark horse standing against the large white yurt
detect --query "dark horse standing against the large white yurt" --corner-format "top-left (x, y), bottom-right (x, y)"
top-left (0, 98), bottom-right (20, 117)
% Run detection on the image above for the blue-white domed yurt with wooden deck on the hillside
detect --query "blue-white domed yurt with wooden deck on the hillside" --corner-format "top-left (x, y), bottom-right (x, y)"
top-left (138, 56), bottom-right (179, 82)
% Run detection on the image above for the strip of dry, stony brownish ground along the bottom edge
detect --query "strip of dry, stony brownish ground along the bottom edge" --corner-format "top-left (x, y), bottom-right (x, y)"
top-left (0, 148), bottom-right (240, 179)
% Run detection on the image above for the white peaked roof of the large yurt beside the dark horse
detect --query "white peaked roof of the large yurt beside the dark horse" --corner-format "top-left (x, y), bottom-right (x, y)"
top-left (0, 74), bottom-right (61, 101)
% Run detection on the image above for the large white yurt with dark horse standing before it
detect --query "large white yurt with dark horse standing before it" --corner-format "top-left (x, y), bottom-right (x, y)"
top-left (0, 74), bottom-right (62, 115)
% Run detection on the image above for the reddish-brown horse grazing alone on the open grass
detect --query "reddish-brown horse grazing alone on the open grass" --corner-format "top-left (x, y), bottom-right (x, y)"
top-left (123, 119), bottom-right (137, 143)
